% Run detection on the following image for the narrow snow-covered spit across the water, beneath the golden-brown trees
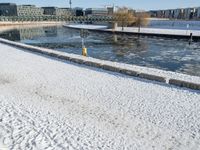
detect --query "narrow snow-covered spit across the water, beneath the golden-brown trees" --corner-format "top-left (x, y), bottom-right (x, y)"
top-left (64, 24), bottom-right (200, 38)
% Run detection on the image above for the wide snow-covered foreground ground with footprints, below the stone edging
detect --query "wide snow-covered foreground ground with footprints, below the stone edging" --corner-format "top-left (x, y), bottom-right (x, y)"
top-left (0, 44), bottom-right (200, 150)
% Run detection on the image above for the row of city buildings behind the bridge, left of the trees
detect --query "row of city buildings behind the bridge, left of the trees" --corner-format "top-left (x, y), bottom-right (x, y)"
top-left (0, 3), bottom-right (114, 16)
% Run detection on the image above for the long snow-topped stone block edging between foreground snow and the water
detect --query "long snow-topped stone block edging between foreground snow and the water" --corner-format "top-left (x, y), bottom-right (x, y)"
top-left (0, 38), bottom-right (200, 90)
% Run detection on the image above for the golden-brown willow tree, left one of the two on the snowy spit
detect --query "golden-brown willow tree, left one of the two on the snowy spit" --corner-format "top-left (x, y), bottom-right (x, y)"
top-left (113, 7), bottom-right (135, 30)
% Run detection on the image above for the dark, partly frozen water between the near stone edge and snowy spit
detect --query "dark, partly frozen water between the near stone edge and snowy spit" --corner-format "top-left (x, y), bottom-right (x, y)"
top-left (0, 26), bottom-right (200, 76)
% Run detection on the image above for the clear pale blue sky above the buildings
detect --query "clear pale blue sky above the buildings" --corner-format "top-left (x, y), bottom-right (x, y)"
top-left (0, 0), bottom-right (200, 10)
